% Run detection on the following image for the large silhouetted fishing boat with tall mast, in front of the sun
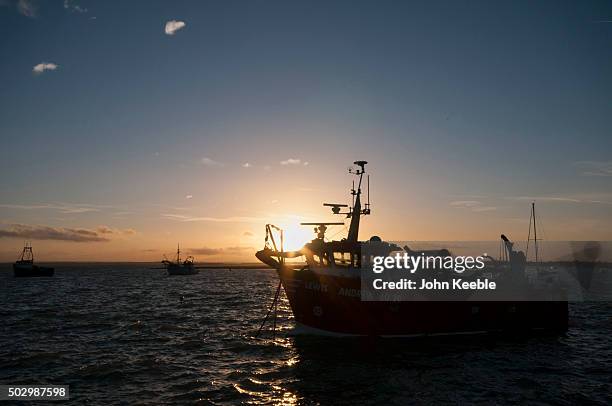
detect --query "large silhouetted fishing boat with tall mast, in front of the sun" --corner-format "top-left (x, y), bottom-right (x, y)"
top-left (256, 161), bottom-right (568, 337)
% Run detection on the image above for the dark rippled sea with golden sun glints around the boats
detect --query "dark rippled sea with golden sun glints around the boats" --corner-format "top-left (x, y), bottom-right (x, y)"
top-left (0, 265), bottom-right (612, 405)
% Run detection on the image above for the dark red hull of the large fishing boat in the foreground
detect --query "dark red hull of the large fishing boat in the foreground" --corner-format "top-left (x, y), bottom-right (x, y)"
top-left (278, 267), bottom-right (568, 337)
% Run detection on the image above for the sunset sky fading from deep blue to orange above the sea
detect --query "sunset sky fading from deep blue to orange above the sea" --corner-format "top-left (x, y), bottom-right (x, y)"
top-left (0, 0), bottom-right (612, 261)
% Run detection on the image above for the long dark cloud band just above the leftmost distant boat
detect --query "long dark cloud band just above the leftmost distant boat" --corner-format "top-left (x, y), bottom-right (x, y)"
top-left (0, 224), bottom-right (134, 242)
